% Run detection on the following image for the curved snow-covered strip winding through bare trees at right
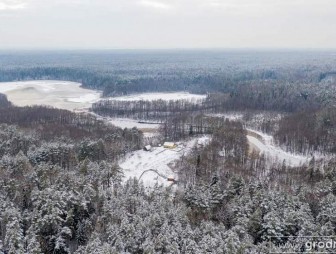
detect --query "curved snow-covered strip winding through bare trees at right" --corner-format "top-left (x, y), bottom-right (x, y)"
top-left (247, 129), bottom-right (310, 167)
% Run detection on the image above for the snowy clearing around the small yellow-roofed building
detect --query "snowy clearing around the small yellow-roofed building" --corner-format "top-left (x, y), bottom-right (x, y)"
top-left (119, 136), bottom-right (210, 187)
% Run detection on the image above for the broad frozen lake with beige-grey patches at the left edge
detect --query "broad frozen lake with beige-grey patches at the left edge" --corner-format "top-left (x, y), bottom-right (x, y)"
top-left (0, 80), bottom-right (101, 110)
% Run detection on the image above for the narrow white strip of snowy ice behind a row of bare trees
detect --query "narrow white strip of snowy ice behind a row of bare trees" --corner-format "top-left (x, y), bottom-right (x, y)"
top-left (107, 92), bottom-right (206, 101)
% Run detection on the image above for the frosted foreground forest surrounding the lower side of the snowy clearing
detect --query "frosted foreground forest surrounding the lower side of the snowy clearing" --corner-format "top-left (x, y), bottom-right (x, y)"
top-left (0, 100), bottom-right (336, 253)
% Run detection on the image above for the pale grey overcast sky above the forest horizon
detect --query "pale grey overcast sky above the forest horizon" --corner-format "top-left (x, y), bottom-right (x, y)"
top-left (0, 0), bottom-right (336, 49)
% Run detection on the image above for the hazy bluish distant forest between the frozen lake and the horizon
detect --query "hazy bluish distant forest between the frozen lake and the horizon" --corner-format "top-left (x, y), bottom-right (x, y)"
top-left (0, 50), bottom-right (336, 96)
